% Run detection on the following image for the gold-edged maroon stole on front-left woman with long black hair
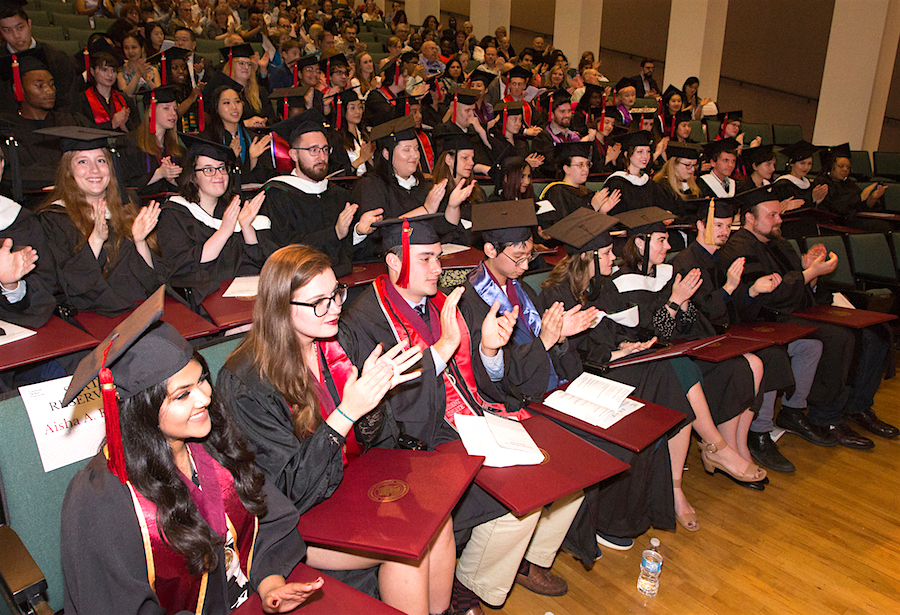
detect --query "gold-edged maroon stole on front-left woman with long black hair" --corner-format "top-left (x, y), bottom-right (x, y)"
top-left (126, 442), bottom-right (259, 614)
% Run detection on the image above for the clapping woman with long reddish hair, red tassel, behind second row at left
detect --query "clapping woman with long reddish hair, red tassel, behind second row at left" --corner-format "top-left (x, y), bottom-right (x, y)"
top-left (122, 85), bottom-right (184, 194)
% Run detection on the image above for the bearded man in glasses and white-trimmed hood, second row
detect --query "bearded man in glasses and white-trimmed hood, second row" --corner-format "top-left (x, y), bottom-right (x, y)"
top-left (265, 110), bottom-right (382, 275)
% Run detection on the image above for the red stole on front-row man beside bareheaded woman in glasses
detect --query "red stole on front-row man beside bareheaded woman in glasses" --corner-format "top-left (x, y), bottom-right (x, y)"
top-left (373, 274), bottom-right (531, 428)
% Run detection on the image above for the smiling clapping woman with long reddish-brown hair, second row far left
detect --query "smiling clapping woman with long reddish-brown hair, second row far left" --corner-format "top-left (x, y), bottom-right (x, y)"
top-left (38, 139), bottom-right (165, 316)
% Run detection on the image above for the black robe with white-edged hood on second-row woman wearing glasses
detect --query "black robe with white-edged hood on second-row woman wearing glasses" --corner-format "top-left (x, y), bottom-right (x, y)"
top-left (156, 197), bottom-right (278, 307)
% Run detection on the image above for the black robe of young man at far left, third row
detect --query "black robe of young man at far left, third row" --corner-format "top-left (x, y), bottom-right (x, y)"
top-left (0, 110), bottom-right (93, 190)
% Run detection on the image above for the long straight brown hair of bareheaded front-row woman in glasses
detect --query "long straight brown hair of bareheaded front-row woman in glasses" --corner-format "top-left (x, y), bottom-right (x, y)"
top-left (232, 244), bottom-right (331, 439)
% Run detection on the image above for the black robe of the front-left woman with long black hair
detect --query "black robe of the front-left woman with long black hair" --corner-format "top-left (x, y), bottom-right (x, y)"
top-left (60, 453), bottom-right (306, 615)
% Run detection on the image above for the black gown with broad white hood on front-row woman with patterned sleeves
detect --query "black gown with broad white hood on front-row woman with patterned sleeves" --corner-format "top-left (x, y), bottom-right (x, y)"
top-left (604, 264), bottom-right (756, 425)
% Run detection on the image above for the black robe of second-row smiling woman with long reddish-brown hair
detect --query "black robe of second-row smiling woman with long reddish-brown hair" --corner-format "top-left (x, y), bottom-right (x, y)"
top-left (38, 205), bottom-right (165, 316)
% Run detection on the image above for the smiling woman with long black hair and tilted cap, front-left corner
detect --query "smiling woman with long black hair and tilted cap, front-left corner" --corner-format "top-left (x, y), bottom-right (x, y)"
top-left (61, 310), bottom-right (323, 615)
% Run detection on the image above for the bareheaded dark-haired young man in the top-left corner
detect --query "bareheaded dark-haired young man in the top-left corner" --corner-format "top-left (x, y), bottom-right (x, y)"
top-left (0, 1), bottom-right (84, 111)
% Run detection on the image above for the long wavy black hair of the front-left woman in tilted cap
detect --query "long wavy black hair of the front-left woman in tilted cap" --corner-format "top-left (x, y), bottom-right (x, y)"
top-left (119, 351), bottom-right (267, 576)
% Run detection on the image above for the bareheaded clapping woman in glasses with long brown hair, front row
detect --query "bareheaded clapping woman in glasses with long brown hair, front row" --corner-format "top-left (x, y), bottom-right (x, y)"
top-left (218, 244), bottom-right (456, 615)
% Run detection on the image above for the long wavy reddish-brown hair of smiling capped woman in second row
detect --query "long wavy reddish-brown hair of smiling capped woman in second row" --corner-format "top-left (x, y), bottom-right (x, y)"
top-left (39, 152), bottom-right (157, 263)
